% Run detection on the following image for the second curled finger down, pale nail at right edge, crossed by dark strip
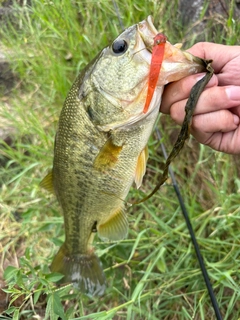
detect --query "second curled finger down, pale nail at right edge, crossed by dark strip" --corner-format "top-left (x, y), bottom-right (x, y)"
top-left (170, 86), bottom-right (240, 124)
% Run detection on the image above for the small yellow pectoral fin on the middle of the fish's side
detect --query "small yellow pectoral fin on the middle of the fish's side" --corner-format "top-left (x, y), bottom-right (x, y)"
top-left (94, 138), bottom-right (122, 171)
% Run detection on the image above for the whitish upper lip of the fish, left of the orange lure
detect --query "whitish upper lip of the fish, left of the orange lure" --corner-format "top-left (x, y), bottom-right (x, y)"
top-left (137, 16), bottom-right (158, 53)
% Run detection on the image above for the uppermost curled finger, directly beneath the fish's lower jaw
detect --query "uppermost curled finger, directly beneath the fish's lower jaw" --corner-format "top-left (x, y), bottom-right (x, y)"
top-left (160, 73), bottom-right (218, 114)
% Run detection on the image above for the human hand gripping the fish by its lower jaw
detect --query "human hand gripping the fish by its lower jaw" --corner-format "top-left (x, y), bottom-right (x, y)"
top-left (160, 42), bottom-right (240, 154)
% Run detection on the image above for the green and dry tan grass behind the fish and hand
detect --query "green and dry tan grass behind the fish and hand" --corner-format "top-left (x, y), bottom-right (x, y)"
top-left (0, 0), bottom-right (240, 320)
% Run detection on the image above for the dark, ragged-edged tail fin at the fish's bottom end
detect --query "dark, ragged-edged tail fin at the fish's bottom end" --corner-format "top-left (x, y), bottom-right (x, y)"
top-left (50, 245), bottom-right (106, 297)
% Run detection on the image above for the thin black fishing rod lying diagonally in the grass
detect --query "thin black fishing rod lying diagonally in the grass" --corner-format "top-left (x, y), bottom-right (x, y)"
top-left (155, 128), bottom-right (222, 320)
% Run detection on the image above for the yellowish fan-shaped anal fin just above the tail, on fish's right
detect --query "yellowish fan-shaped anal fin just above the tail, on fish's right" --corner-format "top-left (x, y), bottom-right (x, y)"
top-left (97, 208), bottom-right (128, 241)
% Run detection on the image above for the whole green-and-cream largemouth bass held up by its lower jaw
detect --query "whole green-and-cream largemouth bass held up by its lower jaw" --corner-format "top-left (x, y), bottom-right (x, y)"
top-left (41, 16), bottom-right (205, 297)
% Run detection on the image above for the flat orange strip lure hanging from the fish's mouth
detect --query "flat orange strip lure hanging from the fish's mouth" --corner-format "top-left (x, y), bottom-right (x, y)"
top-left (143, 33), bottom-right (167, 113)
